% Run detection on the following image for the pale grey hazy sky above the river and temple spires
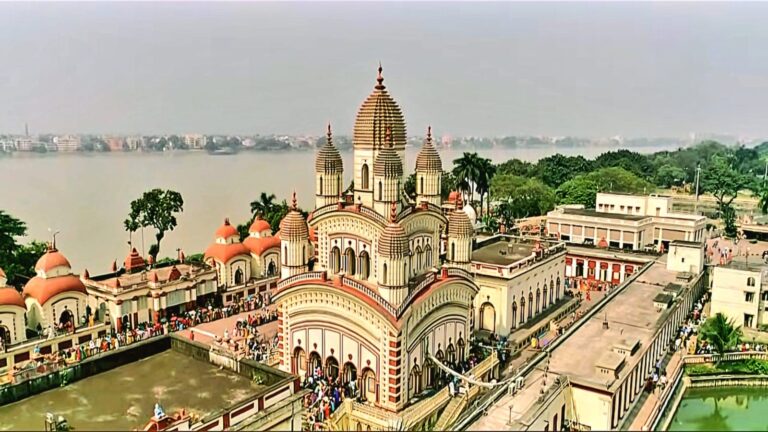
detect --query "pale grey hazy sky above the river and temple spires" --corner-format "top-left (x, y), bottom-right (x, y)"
top-left (0, 3), bottom-right (768, 137)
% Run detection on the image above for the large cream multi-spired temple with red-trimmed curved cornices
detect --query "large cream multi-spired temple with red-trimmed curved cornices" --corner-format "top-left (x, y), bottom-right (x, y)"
top-left (273, 67), bottom-right (486, 430)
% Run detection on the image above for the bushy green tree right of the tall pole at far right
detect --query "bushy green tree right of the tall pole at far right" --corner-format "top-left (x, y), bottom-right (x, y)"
top-left (701, 154), bottom-right (753, 214)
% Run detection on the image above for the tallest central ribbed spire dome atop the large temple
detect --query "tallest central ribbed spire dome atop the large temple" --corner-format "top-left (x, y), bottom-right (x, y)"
top-left (353, 65), bottom-right (406, 152)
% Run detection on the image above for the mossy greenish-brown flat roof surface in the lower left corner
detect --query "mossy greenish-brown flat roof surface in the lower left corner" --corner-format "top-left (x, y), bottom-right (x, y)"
top-left (0, 350), bottom-right (259, 431)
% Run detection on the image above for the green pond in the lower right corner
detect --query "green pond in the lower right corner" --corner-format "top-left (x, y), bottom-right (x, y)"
top-left (669, 387), bottom-right (768, 431)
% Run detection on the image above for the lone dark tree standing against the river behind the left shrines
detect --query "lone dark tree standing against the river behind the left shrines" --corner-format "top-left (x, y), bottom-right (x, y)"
top-left (123, 189), bottom-right (184, 260)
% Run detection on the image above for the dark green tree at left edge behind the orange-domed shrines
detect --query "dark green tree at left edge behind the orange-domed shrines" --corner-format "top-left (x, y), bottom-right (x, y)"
top-left (0, 210), bottom-right (46, 287)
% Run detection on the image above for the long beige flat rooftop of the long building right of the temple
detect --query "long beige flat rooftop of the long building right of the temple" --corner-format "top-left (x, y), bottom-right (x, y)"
top-left (550, 262), bottom-right (688, 390)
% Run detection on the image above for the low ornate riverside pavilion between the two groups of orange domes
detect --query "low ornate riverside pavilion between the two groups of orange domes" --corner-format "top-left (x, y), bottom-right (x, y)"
top-left (80, 248), bottom-right (217, 332)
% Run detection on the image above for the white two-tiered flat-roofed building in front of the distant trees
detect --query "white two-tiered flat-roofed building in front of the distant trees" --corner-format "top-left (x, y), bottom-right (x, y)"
top-left (547, 193), bottom-right (707, 250)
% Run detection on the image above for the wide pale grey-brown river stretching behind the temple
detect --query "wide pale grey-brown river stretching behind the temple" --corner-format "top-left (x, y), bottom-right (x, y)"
top-left (0, 146), bottom-right (662, 275)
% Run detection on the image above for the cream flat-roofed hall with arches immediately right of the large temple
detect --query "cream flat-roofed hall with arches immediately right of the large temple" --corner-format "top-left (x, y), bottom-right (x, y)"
top-left (471, 236), bottom-right (566, 336)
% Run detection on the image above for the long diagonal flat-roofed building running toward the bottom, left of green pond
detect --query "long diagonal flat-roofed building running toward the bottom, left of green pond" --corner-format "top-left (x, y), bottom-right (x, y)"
top-left (469, 243), bottom-right (707, 431)
